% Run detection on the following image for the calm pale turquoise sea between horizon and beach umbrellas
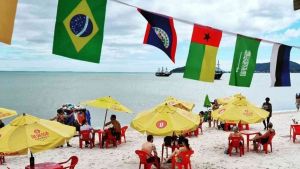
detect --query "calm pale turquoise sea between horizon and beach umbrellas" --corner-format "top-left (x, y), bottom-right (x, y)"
top-left (0, 72), bottom-right (300, 126)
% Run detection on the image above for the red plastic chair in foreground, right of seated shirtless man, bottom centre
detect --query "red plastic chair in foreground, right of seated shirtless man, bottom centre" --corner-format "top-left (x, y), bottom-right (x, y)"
top-left (172, 150), bottom-right (194, 169)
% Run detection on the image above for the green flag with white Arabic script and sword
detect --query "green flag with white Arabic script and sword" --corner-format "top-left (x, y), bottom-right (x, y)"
top-left (229, 35), bottom-right (260, 87)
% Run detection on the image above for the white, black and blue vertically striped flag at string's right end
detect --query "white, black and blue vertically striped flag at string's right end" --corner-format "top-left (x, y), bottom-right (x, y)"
top-left (270, 44), bottom-right (292, 86)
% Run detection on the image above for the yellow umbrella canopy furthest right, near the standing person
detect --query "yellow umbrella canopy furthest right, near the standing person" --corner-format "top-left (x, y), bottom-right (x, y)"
top-left (212, 95), bottom-right (269, 124)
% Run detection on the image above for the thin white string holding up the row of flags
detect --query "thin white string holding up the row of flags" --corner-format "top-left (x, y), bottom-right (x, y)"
top-left (110, 0), bottom-right (300, 49)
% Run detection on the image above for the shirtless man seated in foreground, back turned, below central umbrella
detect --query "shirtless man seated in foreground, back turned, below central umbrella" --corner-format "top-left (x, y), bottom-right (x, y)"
top-left (142, 135), bottom-right (160, 169)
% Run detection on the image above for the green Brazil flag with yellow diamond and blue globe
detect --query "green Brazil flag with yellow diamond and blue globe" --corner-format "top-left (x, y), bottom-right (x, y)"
top-left (53, 0), bottom-right (107, 63)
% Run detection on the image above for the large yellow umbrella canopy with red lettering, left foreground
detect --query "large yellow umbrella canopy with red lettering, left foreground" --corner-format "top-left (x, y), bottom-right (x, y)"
top-left (0, 114), bottom-right (76, 155)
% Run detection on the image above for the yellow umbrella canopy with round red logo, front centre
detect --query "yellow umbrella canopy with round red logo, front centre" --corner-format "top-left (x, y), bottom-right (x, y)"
top-left (131, 104), bottom-right (200, 136)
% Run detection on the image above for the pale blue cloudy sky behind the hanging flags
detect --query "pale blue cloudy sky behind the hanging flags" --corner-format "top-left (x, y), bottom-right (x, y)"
top-left (0, 0), bottom-right (300, 72)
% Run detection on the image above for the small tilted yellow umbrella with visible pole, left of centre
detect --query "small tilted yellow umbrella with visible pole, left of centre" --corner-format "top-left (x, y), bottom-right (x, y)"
top-left (80, 96), bottom-right (131, 128)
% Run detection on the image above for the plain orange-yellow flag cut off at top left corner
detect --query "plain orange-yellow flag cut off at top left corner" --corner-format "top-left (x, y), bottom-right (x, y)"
top-left (0, 0), bottom-right (18, 44)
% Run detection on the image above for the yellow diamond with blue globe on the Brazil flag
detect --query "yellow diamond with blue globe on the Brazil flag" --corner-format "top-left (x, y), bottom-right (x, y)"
top-left (64, 0), bottom-right (99, 52)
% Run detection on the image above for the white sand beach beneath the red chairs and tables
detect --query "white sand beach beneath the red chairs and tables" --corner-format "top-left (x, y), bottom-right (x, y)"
top-left (0, 112), bottom-right (300, 169)
